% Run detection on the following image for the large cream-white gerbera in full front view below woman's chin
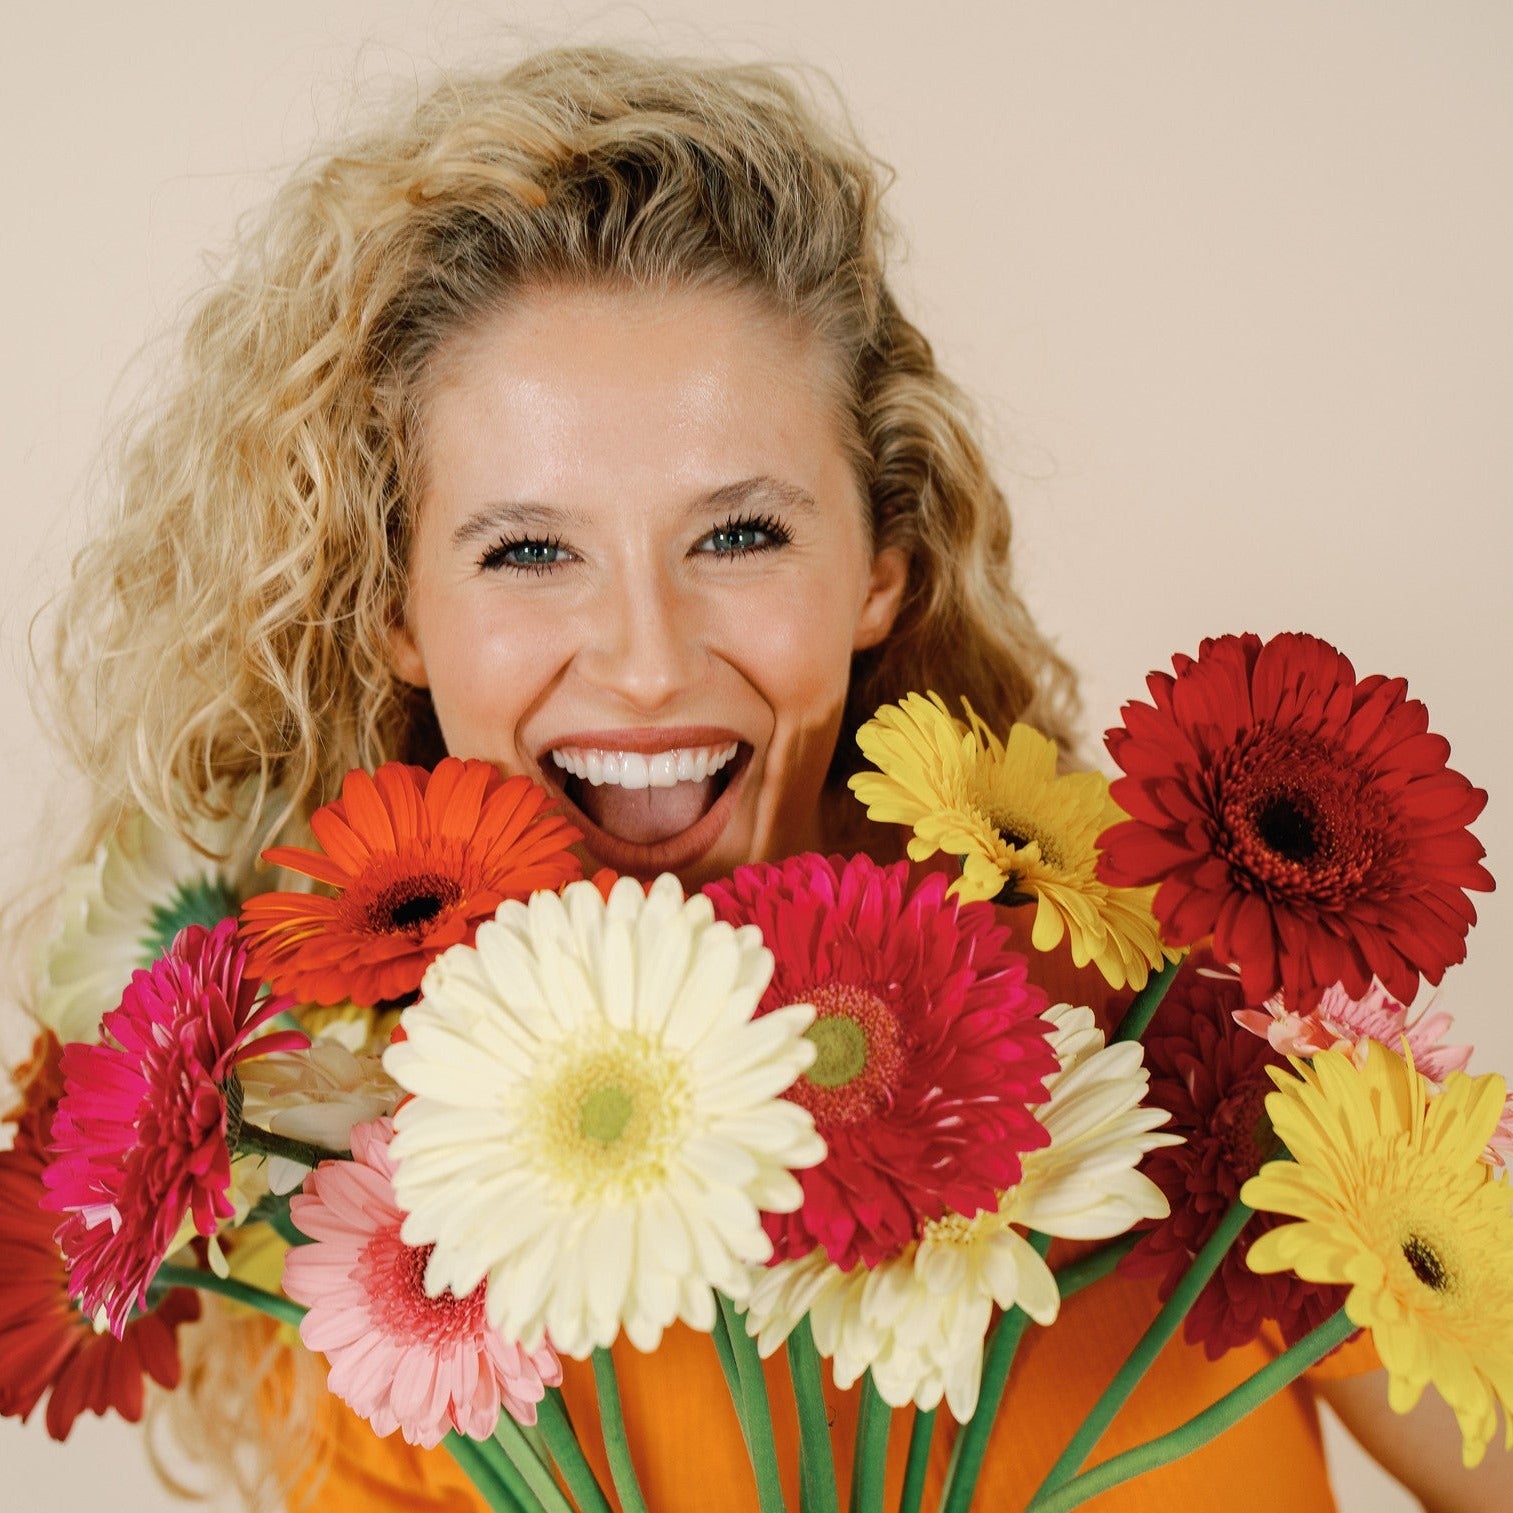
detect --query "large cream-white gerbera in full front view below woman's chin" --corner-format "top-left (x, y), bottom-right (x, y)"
top-left (384, 875), bottom-right (825, 1359)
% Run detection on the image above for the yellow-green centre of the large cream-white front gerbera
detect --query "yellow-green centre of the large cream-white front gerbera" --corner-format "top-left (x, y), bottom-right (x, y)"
top-left (531, 1032), bottom-right (693, 1203)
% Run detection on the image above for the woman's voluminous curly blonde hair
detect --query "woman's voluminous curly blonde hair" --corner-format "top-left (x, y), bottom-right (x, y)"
top-left (47, 47), bottom-right (1076, 865)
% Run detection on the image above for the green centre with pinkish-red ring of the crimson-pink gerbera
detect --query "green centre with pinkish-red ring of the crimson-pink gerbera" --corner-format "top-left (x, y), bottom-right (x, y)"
top-left (787, 982), bottom-right (905, 1132)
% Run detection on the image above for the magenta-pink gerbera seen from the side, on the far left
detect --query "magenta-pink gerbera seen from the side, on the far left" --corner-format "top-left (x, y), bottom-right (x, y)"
top-left (42, 920), bottom-right (307, 1337)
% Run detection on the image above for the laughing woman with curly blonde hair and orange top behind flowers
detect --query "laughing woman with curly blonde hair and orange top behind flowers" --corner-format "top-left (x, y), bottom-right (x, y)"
top-left (29, 41), bottom-right (1498, 1508)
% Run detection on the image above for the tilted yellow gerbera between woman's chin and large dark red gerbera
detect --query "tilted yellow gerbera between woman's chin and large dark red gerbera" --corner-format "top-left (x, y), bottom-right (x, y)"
top-left (849, 693), bottom-right (1165, 990)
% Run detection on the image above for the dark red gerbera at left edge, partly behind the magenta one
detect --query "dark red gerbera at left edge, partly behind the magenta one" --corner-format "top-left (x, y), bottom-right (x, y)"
top-left (0, 1041), bottom-right (200, 1439)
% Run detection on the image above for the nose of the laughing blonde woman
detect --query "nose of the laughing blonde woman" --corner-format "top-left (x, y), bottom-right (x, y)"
top-left (575, 572), bottom-right (705, 714)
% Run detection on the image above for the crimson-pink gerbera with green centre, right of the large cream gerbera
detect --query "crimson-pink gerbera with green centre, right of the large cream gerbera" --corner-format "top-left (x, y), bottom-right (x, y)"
top-left (704, 855), bottom-right (1056, 1269)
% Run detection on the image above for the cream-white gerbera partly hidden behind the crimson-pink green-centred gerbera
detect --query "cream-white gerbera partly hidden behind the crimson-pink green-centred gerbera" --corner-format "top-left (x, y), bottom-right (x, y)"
top-left (746, 1003), bottom-right (1180, 1424)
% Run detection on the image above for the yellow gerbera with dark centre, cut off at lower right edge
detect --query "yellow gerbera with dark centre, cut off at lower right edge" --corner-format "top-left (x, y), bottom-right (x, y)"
top-left (1241, 1042), bottom-right (1513, 1466)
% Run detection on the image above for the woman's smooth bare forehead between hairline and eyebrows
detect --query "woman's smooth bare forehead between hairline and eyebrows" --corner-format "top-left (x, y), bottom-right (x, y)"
top-left (422, 286), bottom-right (846, 504)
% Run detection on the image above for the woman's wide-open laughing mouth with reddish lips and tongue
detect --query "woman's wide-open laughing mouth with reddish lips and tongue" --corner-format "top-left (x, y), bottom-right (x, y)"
top-left (537, 726), bottom-right (752, 879)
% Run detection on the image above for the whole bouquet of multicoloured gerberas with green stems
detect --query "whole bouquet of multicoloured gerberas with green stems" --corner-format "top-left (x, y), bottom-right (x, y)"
top-left (0, 634), bottom-right (1513, 1513)
